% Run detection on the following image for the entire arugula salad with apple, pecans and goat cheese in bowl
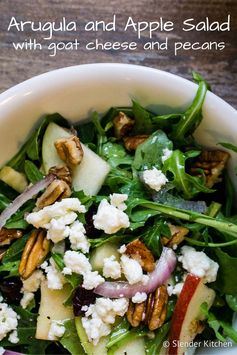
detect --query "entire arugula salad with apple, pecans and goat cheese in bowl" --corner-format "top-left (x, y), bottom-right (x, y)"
top-left (0, 73), bottom-right (237, 355)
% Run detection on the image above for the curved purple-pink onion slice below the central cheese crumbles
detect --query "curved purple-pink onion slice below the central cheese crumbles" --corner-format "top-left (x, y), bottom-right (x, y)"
top-left (94, 247), bottom-right (176, 298)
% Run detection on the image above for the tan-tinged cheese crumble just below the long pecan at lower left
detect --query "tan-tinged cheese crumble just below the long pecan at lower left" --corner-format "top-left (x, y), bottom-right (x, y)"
top-left (20, 270), bottom-right (44, 309)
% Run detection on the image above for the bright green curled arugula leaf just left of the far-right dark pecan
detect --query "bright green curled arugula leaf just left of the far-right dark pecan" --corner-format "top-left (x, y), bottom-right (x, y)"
top-left (163, 149), bottom-right (213, 199)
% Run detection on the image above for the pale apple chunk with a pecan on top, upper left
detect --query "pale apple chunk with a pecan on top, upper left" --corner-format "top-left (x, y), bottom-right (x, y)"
top-left (42, 122), bottom-right (110, 196)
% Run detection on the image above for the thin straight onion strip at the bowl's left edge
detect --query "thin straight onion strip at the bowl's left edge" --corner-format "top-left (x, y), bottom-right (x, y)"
top-left (0, 174), bottom-right (56, 229)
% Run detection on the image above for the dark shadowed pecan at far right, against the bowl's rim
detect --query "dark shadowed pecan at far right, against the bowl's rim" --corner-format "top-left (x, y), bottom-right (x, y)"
top-left (190, 150), bottom-right (230, 188)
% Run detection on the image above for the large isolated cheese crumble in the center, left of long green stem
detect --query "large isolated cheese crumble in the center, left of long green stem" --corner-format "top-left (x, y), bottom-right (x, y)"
top-left (93, 199), bottom-right (130, 234)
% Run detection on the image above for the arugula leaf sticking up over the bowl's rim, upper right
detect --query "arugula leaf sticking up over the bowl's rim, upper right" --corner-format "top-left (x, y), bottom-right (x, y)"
top-left (171, 72), bottom-right (209, 146)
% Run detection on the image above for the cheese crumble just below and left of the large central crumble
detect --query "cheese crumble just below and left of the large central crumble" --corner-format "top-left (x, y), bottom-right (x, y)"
top-left (69, 221), bottom-right (90, 253)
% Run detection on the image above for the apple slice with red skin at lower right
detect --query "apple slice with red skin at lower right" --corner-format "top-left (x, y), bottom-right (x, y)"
top-left (168, 274), bottom-right (215, 355)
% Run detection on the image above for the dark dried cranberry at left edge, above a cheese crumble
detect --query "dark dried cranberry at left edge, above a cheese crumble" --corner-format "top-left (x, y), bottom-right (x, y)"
top-left (0, 277), bottom-right (22, 304)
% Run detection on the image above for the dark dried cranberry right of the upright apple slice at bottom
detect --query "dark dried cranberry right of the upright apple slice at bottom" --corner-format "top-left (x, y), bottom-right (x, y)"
top-left (72, 286), bottom-right (96, 316)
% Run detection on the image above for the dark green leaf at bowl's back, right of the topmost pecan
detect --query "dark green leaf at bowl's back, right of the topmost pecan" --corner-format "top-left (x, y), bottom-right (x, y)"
top-left (132, 101), bottom-right (153, 135)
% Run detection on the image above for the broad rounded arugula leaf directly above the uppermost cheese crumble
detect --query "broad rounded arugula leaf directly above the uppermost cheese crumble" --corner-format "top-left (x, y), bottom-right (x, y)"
top-left (133, 130), bottom-right (173, 170)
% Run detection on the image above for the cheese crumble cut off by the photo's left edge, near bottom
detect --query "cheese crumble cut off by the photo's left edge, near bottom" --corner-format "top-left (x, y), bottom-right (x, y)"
top-left (0, 303), bottom-right (18, 341)
